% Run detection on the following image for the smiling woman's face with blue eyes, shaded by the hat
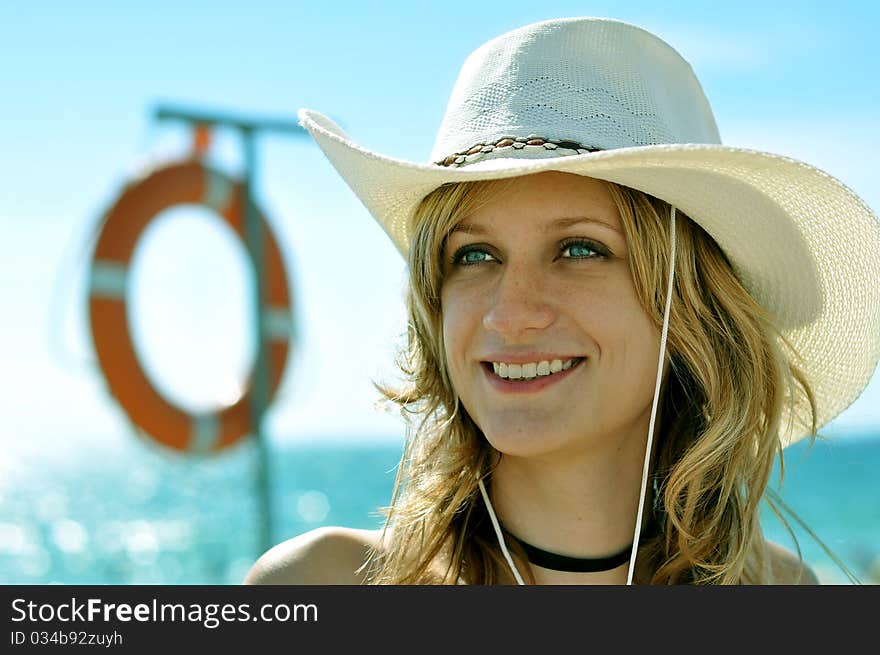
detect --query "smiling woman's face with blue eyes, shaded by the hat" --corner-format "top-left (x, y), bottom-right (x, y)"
top-left (441, 171), bottom-right (660, 456)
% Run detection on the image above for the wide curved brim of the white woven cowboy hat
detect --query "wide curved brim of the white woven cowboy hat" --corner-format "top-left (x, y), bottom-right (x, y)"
top-left (299, 109), bottom-right (880, 445)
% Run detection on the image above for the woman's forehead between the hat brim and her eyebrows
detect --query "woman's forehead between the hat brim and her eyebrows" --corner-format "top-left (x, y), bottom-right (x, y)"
top-left (453, 171), bottom-right (622, 234)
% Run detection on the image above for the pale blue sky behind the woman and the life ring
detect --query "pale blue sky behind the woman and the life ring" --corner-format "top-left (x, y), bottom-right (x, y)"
top-left (0, 0), bottom-right (880, 443)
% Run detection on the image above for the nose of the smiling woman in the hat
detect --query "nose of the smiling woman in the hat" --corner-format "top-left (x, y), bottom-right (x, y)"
top-left (483, 264), bottom-right (556, 341)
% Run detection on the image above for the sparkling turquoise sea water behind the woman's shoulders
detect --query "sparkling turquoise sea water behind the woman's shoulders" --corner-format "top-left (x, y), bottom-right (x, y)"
top-left (0, 436), bottom-right (880, 584)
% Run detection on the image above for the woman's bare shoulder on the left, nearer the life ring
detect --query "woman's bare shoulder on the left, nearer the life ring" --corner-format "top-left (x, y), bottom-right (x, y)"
top-left (244, 527), bottom-right (382, 585)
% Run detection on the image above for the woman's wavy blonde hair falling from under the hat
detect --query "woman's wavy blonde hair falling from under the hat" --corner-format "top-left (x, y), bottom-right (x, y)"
top-left (366, 179), bottom-right (815, 584)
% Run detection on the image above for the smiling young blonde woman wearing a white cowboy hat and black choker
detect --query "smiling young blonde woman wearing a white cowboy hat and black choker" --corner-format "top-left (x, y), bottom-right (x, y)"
top-left (246, 19), bottom-right (880, 584)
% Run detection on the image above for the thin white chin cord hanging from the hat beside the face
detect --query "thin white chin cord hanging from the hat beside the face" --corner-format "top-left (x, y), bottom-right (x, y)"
top-left (477, 207), bottom-right (675, 585)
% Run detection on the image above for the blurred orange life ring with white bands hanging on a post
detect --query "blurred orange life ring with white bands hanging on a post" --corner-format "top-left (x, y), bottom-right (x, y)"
top-left (89, 159), bottom-right (293, 453)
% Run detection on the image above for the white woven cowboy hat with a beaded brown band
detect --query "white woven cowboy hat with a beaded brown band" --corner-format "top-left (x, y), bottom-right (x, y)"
top-left (299, 18), bottom-right (880, 444)
